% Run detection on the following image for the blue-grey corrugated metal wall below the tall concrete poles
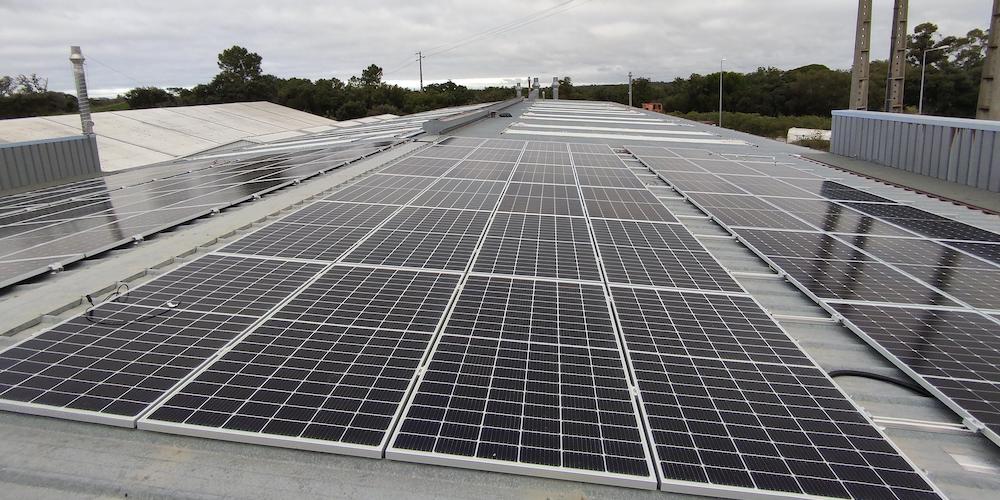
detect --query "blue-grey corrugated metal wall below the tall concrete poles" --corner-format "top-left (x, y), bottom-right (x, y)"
top-left (830, 111), bottom-right (1000, 193)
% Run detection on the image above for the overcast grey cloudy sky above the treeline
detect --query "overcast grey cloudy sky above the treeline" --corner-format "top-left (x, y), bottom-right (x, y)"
top-left (0, 0), bottom-right (992, 96)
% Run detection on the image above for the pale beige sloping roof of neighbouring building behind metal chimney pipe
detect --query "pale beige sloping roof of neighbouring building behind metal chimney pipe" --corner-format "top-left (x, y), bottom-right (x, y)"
top-left (0, 102), bottom-right (340, 172)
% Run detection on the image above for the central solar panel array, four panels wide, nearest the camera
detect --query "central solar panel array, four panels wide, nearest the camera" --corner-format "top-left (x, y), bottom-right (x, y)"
top-left (0, 126), bottom-right (938, 498)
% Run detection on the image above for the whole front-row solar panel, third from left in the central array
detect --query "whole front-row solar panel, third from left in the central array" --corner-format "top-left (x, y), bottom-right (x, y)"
top-left (386, 276), bottom-right (656, 488)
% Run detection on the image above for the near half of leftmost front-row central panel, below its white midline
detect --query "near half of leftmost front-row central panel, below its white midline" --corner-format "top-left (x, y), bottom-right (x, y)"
top-left (0, 302), bottom-right (257, 427)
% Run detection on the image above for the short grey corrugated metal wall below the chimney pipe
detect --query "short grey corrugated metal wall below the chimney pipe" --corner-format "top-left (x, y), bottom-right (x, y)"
top-left (0, 135), bottom-right (101, 193)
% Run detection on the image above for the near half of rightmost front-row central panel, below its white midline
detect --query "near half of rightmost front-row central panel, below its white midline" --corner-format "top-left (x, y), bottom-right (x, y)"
top-left (630, 352), bottom-right (938, 498)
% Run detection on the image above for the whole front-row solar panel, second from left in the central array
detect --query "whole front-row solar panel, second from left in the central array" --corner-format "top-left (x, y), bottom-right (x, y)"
top-left (140, 266), bottom-right (458, 457)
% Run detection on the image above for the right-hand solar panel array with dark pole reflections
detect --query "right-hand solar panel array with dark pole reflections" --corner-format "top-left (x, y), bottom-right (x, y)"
top-left (636, 147), bottom-right (1000, 450)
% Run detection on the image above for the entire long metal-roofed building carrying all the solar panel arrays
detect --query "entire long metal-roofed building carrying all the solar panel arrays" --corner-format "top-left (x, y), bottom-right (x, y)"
top-left (0, 90), bottom-right (1000, 499)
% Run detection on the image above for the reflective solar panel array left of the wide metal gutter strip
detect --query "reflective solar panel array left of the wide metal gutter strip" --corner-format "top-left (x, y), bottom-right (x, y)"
top-left (0, 107), bottom-right (492, 288)
